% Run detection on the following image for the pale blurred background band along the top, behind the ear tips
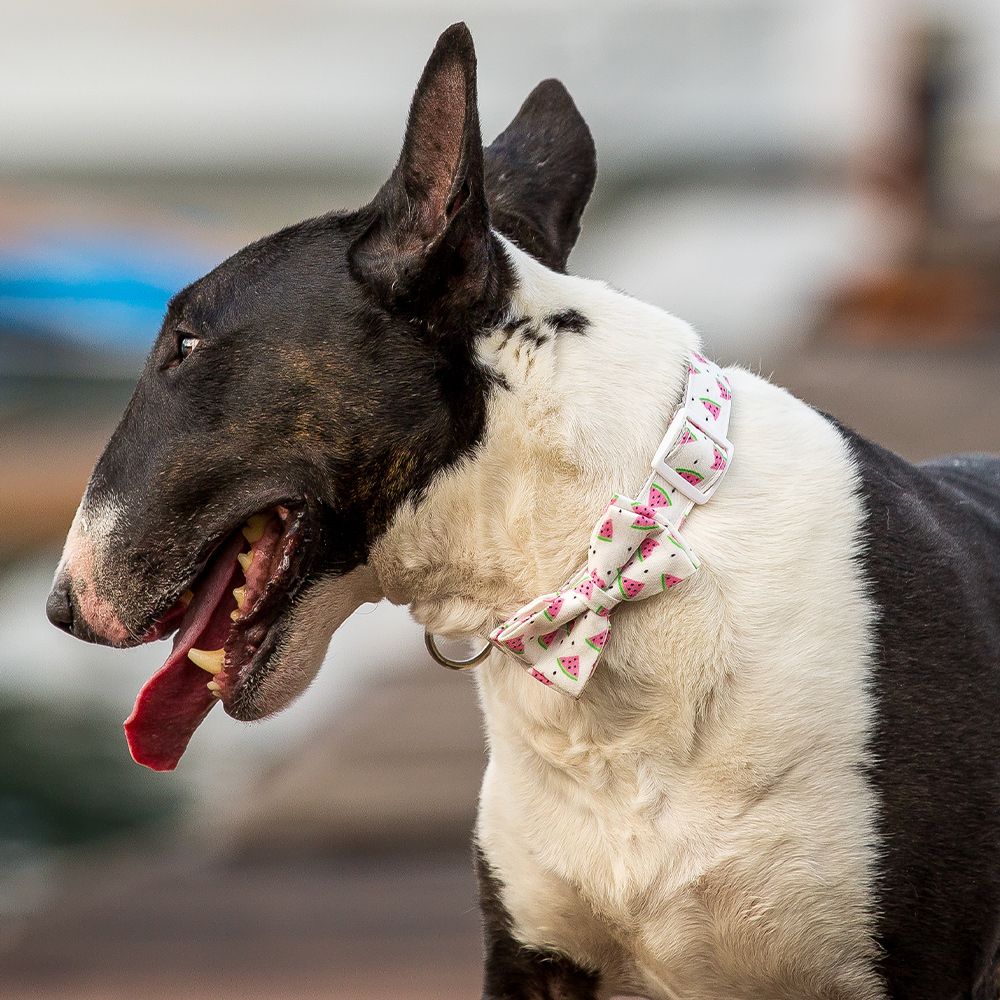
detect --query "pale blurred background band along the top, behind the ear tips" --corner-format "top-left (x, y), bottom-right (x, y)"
top-left (0, 0), bottom-right (972, 171)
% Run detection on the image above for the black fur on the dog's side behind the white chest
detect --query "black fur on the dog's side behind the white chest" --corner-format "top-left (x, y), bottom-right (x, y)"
top-left (845, 432), bottom-right (1000, 1000)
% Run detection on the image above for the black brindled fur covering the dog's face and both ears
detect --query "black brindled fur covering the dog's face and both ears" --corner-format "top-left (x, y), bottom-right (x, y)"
top-left (49, 25), bottom-right (593, 656)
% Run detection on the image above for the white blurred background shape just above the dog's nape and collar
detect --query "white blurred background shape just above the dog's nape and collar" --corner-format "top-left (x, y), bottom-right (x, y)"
top-left (573, 185), bottom-right (905, 356)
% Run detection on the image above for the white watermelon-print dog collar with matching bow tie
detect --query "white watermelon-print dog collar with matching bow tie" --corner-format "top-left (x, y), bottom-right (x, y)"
top-left (490, 353), bottom-right (733, 698)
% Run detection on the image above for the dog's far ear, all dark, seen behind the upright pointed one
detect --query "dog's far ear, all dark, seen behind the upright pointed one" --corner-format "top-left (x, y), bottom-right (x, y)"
top-left (485, 80), bottom-right (597, 271)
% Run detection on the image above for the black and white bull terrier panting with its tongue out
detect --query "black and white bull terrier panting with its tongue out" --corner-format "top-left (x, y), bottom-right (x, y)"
top-left (47, 24), bottom-right (1000, 1000)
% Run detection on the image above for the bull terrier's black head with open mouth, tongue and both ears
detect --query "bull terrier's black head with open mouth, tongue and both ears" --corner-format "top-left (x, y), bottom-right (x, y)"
top-left (47, 25), bottom-right (595, 769)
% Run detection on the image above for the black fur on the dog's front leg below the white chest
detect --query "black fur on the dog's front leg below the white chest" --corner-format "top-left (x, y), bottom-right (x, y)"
top-left (475, 848), bottom-right (600, 1000)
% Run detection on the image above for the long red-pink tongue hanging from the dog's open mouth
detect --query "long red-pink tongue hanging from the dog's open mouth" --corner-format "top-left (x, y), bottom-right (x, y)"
top-left (125, 532), bottom-right (246, 771)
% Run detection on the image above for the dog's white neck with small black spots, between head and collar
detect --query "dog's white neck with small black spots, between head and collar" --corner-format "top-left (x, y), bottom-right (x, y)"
top-left (370, 243), bottom-right (698, 636)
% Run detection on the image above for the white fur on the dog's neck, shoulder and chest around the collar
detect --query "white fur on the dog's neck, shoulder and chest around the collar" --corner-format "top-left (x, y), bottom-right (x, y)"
top-left (371, 247), bottom-right (883, 1000)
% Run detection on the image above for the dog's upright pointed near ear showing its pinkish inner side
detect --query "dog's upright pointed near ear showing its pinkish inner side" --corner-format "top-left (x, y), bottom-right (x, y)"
top-left (350, 24), bottom-right (496, 328)
